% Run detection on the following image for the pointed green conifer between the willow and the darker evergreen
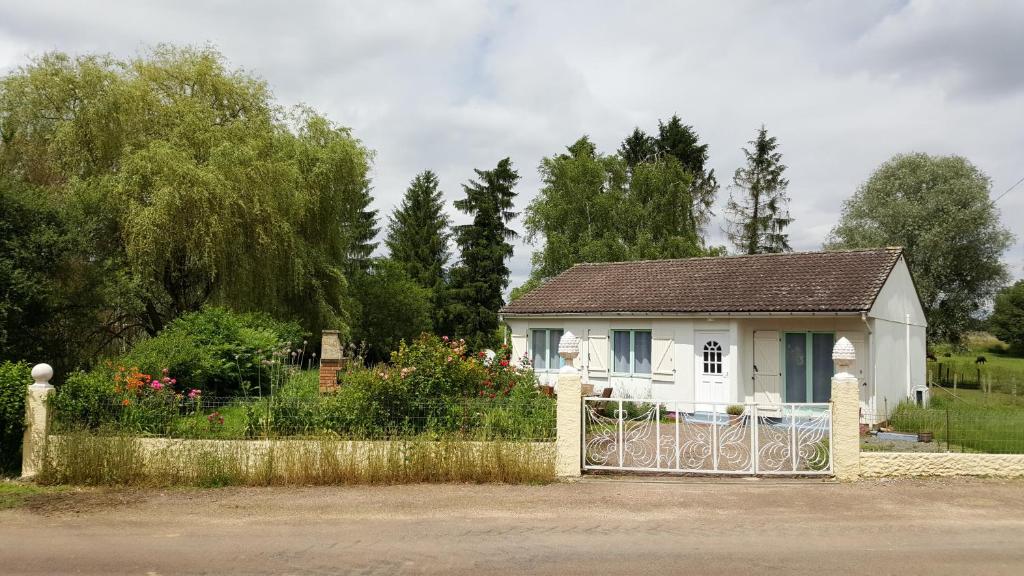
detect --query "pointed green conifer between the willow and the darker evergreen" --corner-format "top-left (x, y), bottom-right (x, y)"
top-left (384, 170), bottom-right (451, 326)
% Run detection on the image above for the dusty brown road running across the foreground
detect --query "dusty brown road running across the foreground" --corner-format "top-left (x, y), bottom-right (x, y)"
top-left (0, 479), bottom-right (1024, 576)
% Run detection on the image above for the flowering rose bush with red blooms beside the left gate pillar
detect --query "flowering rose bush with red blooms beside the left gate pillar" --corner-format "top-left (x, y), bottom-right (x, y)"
top-left (307, 334), bottom-right (554, 438)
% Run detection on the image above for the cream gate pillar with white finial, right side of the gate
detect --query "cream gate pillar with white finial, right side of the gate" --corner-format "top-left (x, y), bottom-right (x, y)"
top-left (831, 338), bottom-right (860, 482)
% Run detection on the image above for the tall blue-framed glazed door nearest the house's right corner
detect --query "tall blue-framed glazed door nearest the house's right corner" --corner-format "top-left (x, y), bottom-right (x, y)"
top-left (782, 332), bottom-right (835, 402)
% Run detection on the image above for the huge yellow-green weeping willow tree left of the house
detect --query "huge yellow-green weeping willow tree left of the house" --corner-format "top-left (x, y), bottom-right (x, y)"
top-left (0, 46), bottom-right (373, 352)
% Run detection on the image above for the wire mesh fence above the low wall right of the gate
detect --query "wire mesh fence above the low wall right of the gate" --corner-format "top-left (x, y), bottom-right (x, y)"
top-left (861, 404), bottom-right (1024, 454)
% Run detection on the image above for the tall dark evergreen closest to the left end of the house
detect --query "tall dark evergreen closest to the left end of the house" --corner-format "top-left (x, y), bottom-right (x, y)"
top-left (449, 158), bottom-right (519, 349)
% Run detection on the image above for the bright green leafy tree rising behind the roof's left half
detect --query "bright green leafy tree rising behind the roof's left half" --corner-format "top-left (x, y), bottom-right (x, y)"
top-left (525, 136), bottom-right (707, 279)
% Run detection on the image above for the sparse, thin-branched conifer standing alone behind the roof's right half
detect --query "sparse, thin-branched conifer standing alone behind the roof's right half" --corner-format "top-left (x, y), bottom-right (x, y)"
top-left (726, 125), bottom-right (793, 254)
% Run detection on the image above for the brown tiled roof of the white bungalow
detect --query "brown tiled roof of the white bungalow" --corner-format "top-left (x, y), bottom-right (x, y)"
top-left (502, 248), bottom-right (903, 315)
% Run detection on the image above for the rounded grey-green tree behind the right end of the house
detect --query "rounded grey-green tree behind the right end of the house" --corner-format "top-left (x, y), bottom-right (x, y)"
top-left (826, 154), bottom-right (1013, 342)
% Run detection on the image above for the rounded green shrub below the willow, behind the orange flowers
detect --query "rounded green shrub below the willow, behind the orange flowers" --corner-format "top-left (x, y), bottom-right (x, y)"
top-left (119, 307), bottom-right (309, 396)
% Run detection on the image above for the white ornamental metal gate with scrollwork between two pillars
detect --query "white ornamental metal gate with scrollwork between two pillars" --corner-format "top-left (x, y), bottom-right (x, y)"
top-left (583, 397), bottom-right (833, 476)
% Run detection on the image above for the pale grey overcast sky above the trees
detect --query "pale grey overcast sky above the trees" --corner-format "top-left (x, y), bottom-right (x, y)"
top-left (0, 0), bottom-right (1024, 286)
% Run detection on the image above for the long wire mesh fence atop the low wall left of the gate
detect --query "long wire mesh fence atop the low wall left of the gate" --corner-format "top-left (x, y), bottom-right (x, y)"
top-left (53, 395), bottom-right (556, 441)
